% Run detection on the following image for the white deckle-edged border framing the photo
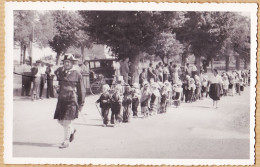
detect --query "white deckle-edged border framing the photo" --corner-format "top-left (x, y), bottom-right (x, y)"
top-left (4, 2), bottom-right (258, 165)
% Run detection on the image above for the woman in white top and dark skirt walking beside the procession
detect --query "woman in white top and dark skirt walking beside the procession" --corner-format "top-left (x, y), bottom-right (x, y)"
top-left (209, 69), bottom-right (222, 108)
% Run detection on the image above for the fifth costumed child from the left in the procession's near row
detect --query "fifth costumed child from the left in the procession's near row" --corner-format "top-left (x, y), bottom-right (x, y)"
top-left (140, 81), bottom-right (151, 118)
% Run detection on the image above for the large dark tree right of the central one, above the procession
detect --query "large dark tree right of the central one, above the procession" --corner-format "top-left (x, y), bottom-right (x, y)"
top-left (173, 12), bottom-right (237, 72)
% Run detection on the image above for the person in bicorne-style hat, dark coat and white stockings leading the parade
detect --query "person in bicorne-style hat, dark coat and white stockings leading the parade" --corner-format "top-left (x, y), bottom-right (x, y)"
top-left (54, 54), bottom-right (85, 148)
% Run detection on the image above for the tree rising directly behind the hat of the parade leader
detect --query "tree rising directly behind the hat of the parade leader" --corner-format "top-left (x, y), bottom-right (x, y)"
top-left (48, 11), bottom-right (79, 65)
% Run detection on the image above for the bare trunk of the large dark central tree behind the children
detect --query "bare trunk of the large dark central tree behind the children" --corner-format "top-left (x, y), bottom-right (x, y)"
top-left (130, 53), bottom-right (140, 84)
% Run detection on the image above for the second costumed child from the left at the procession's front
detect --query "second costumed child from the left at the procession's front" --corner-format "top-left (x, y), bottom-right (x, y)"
top-left (110, 84), bottom-right (123, 126)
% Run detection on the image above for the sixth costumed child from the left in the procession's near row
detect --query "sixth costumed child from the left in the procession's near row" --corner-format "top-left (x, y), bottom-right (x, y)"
top-left (150, 82), bottom-right (161, 116)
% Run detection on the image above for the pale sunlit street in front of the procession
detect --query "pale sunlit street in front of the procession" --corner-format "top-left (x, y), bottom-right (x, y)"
top-left (13, 87), bottom-right (250, 159)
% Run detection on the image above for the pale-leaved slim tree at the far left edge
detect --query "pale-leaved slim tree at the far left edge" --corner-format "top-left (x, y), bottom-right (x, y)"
top-left (14, 10), bottom-right (36, 64)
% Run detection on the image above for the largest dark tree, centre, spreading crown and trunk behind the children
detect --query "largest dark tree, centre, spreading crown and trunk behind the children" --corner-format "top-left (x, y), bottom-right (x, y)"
top-left (79, 11), bottom-right (175, 82)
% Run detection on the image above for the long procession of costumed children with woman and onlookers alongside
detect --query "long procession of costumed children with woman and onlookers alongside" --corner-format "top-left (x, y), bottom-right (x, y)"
top-left (96, 62), bottom-right (250, 127)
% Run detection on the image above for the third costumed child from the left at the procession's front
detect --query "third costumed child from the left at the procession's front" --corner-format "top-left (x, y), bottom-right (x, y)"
top-left (123, 85), bottom-right (132, 122)
